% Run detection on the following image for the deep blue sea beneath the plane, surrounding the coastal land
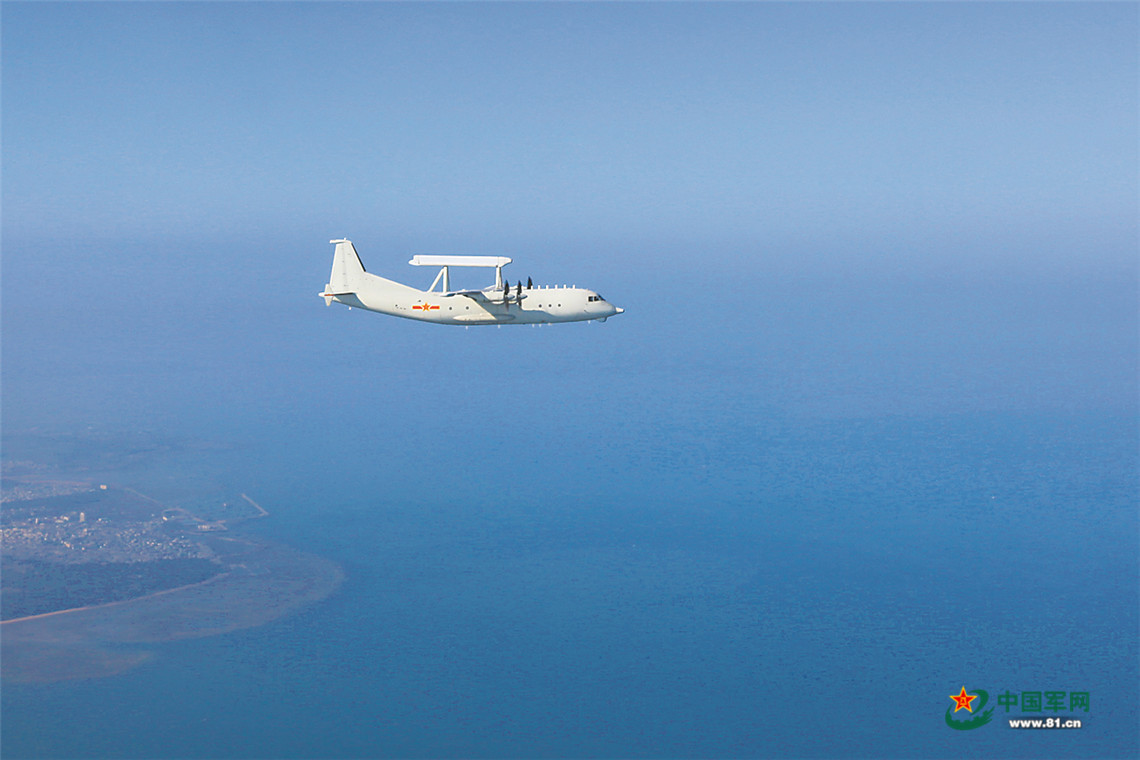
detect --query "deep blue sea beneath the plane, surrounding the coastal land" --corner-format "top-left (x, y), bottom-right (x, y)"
top-left (0, 235), bottom-right (1140, 759)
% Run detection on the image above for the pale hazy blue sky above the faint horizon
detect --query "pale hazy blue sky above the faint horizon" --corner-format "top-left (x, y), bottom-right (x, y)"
top-left (3, 3), bottom-right (1138, 265)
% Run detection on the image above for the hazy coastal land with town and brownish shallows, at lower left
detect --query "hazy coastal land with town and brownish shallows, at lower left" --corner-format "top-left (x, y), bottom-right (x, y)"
top-left (0, 473), bottom-right (343, 683)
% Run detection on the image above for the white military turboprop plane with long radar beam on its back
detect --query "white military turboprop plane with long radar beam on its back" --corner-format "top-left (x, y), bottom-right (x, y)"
top-left (318, 239), bottom-right (625, 326)
